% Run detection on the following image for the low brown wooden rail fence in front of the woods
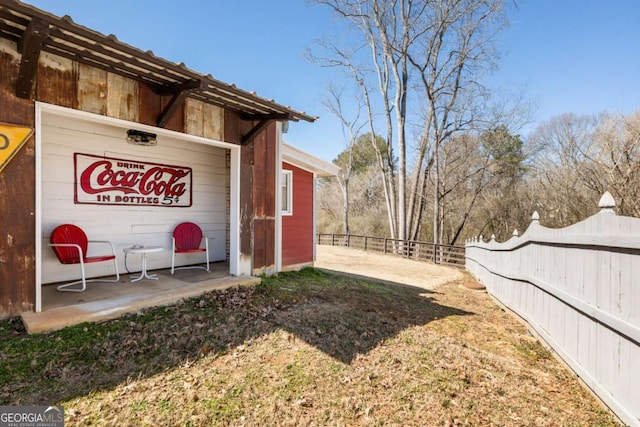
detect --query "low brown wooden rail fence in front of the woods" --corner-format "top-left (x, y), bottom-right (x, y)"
top-left (317, 233), bottom-right (465, 268)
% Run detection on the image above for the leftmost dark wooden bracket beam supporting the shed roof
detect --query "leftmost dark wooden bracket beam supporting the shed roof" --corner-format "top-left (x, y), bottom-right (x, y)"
top-left (16, 18), bottom-right (49, 99)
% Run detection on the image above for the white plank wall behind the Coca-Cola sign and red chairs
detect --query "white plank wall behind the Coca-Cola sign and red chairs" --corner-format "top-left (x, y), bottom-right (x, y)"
top-left (41, 113), bottom-right (229, 283)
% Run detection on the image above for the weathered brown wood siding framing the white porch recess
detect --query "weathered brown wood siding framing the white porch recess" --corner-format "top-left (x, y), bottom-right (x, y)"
top-left (0, 39), bottom-right (276, 317)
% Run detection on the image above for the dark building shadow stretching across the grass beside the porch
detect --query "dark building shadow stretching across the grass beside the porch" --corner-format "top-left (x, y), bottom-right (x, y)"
top-left (0, 269), bottom-right (472, 405)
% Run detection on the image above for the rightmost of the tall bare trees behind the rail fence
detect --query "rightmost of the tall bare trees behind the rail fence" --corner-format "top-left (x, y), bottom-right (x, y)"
top-left (408, 0), bottom-right (506, 243)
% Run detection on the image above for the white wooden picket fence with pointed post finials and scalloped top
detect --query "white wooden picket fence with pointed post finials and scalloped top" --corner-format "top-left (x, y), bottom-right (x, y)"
top-left (466, 192), bottom-right (640, 426)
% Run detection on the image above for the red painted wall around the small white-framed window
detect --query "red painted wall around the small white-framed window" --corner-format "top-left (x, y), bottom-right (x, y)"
top-left (282, 162), bottom-right (315, 266)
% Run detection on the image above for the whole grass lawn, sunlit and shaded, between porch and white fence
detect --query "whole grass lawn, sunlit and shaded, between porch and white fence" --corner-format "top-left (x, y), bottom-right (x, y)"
top-left (0, 269), bottom-right (617, 426)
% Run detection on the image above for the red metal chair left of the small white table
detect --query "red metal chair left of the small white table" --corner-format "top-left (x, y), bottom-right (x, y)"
top-left (49, 224), bottom-right (120, 292)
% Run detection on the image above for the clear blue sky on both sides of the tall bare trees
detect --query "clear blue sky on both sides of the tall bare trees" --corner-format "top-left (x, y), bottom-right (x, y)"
top-left (25, 0), bottom-right (640, 161)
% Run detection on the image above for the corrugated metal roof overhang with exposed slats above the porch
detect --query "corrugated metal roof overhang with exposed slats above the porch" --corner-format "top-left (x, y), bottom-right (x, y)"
top-left (0, 0), bottom-right (317, 122)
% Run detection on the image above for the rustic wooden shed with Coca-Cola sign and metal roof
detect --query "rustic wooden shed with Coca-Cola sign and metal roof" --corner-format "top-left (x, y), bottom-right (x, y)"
top-left (0, 0), bottom-right (316, 317)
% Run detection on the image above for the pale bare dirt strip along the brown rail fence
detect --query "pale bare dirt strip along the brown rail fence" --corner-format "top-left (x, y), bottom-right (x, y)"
top-left (315, 245), bottom-right (464, 289)
